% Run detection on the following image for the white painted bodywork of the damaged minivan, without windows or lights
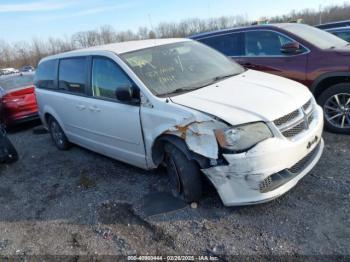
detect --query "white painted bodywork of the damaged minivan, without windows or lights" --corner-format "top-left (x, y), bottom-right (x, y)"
top-left (36, 39), bottom-right (323, 205)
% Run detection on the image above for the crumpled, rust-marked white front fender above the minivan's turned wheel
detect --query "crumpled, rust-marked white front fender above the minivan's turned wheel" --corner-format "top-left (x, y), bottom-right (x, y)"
top-left (141, 98), bottom-right (227, 168)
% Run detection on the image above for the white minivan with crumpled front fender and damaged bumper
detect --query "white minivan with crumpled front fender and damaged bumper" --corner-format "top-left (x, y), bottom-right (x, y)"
top-left (35, 39), bottom-right (324, 206)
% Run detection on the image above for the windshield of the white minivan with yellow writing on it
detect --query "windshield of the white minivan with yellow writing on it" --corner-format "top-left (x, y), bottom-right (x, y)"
top-left (121, 41), bottom-right (244, 96)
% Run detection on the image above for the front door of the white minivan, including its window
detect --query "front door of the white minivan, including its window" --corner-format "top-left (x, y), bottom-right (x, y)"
top-left (83, 57), bottom-right (146, 167)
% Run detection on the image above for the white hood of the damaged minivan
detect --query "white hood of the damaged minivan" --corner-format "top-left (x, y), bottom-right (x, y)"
top-left (171, 70), bottom-right (312, 125)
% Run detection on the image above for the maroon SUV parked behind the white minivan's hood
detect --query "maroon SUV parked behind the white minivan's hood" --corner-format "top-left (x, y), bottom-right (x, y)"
top-left (191, 23), bottom-right (350, 134)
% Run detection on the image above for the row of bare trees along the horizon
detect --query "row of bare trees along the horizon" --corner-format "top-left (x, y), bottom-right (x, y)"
top-left (0, 3), bottom-right (350, 67)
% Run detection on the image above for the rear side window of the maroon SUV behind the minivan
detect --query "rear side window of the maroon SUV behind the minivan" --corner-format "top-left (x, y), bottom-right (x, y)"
top-left (199, 33), bottom-right (242, 56)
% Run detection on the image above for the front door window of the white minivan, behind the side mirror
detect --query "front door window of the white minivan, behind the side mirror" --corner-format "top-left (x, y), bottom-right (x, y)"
top-left (91, 57), bottom-right (132, 100)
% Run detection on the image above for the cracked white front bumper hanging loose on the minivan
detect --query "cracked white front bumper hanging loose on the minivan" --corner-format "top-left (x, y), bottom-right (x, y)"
top-left (202, 105), bottom-right (324, 206)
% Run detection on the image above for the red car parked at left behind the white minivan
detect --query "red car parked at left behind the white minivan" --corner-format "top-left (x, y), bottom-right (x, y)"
top-left (0, 73), bottom-right (38, 126)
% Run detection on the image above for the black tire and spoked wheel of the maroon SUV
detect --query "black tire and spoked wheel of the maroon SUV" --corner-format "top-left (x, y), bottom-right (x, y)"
top-left (318, 83), bottom-right (350, 134)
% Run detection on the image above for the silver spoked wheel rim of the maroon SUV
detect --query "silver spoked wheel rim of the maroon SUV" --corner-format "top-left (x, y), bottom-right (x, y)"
top-left (324, 93), bottom-right (350, 128)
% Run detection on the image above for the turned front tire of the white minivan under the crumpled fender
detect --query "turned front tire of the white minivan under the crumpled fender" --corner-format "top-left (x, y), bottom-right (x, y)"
top-left (164, 143), bottom-right (202, 203)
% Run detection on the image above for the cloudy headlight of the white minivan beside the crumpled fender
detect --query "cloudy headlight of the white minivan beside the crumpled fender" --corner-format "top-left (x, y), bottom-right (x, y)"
top-left (215, 122), bottom-right (273, 152)
